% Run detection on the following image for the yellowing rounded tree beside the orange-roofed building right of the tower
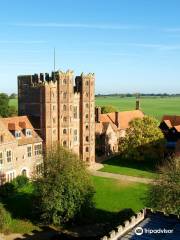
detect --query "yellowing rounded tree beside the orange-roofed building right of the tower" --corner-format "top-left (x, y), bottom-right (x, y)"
top-left (119, 116), bottom-right (165, 162)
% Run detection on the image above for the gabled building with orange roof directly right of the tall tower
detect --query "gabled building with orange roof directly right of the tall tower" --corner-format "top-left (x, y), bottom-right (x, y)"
top-left (95, 107), bottom-right (144, 155)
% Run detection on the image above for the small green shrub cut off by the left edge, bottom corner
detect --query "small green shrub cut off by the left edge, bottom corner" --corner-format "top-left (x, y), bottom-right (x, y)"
top-left (0, 203), bottom-right (12, 232)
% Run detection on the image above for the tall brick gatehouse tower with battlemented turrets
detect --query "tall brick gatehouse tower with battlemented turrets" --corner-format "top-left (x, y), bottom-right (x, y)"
top-left (18, 70), bottom-right (95, 165)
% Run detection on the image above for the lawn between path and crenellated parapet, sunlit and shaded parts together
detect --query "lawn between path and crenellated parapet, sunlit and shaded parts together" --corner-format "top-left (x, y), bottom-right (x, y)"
top-left (89, 176), bottom-right (149, 227)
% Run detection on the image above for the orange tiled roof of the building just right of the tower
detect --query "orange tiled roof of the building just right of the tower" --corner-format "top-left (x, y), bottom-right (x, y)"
top-left (100, 110), bottom-right (144, 129)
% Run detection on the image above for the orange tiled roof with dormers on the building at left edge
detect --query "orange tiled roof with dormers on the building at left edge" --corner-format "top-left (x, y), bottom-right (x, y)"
top-left (0, 116), bottom-right (42, 145)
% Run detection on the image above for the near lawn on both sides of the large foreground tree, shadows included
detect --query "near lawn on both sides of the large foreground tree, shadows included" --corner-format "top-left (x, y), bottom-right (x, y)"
top-left (0, 176), bottom-right (148, 233)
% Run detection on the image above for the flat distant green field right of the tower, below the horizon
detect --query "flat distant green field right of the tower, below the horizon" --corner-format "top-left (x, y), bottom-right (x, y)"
top-left (96, 96), bottom-right (180, 120)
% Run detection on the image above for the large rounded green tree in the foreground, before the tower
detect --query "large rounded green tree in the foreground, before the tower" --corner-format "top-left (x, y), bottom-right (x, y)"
top-left (35, 146), bottom-right (94, 225)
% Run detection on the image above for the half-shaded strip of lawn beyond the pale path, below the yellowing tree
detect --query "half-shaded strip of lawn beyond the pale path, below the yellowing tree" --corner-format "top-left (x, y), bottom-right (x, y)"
top-left (100, 156), bottom-right (157, 178)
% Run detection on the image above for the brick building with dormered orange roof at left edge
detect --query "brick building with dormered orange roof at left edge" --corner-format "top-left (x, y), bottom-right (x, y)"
top-left (0, 116), bottom-right (43, 184)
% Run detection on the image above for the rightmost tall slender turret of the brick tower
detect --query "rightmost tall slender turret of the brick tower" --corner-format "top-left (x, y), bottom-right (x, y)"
top-left (76, 73), bottom-right (95, 165)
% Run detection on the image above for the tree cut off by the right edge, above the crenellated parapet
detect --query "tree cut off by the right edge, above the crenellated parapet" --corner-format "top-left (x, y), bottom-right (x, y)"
top-left (146, 159), bottom-right (180, 215)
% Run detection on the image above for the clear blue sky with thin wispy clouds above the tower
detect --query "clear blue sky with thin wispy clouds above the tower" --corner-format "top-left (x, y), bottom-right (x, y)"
top-left (0, 0), bottom-right (180, 93)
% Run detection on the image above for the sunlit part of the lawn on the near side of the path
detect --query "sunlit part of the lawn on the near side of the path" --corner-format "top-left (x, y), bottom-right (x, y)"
top-left (92, 176), bottom-right (148, 212)
